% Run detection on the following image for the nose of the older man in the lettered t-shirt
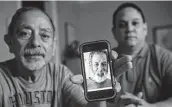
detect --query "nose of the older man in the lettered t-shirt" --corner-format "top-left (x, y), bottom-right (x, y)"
top-left (30, 33), bottom-right (40, 48)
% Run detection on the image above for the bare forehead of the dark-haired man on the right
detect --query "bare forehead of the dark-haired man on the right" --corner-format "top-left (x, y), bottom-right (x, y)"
top-left (116, 7), bottom-right (143, 22)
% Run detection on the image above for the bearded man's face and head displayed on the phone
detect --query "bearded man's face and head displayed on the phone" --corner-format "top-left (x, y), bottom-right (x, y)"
top-left (91, 52), bottom-right (108, 83)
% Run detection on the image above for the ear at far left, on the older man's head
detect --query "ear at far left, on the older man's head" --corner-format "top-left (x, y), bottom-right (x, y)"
top-left (4, 34), bottom-right (13, 53)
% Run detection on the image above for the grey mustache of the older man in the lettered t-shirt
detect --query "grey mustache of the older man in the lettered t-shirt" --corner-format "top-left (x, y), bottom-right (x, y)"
top-left (24, 48), bottom-right (45, 56)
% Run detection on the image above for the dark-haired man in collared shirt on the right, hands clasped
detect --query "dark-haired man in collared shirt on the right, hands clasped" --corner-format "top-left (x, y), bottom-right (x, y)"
top-left (112, 3), bottom-right (172, 107)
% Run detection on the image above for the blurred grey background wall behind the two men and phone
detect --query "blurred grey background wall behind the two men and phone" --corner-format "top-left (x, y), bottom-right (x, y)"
top-left (0, 1), bottom-right (172, 107)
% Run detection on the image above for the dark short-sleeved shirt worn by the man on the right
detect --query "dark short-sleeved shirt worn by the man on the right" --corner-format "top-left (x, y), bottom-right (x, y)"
top-left (114, 44), bottom-right (172, 103)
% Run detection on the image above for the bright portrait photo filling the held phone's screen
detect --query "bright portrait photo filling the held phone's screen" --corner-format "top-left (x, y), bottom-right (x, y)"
top-left (83, 49), bottom-right (112, 92)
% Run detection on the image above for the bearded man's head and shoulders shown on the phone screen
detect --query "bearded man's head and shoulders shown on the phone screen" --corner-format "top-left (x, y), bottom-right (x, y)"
top-left (87, 51), bottom-right (112, 91)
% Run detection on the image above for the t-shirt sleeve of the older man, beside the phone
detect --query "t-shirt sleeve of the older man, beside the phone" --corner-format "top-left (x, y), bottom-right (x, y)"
top-left (62, 66), bottom-right (87, 107)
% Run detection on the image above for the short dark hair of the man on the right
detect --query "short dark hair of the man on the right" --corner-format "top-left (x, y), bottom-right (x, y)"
top-left (112, 3), bottom-right (146, 27)
